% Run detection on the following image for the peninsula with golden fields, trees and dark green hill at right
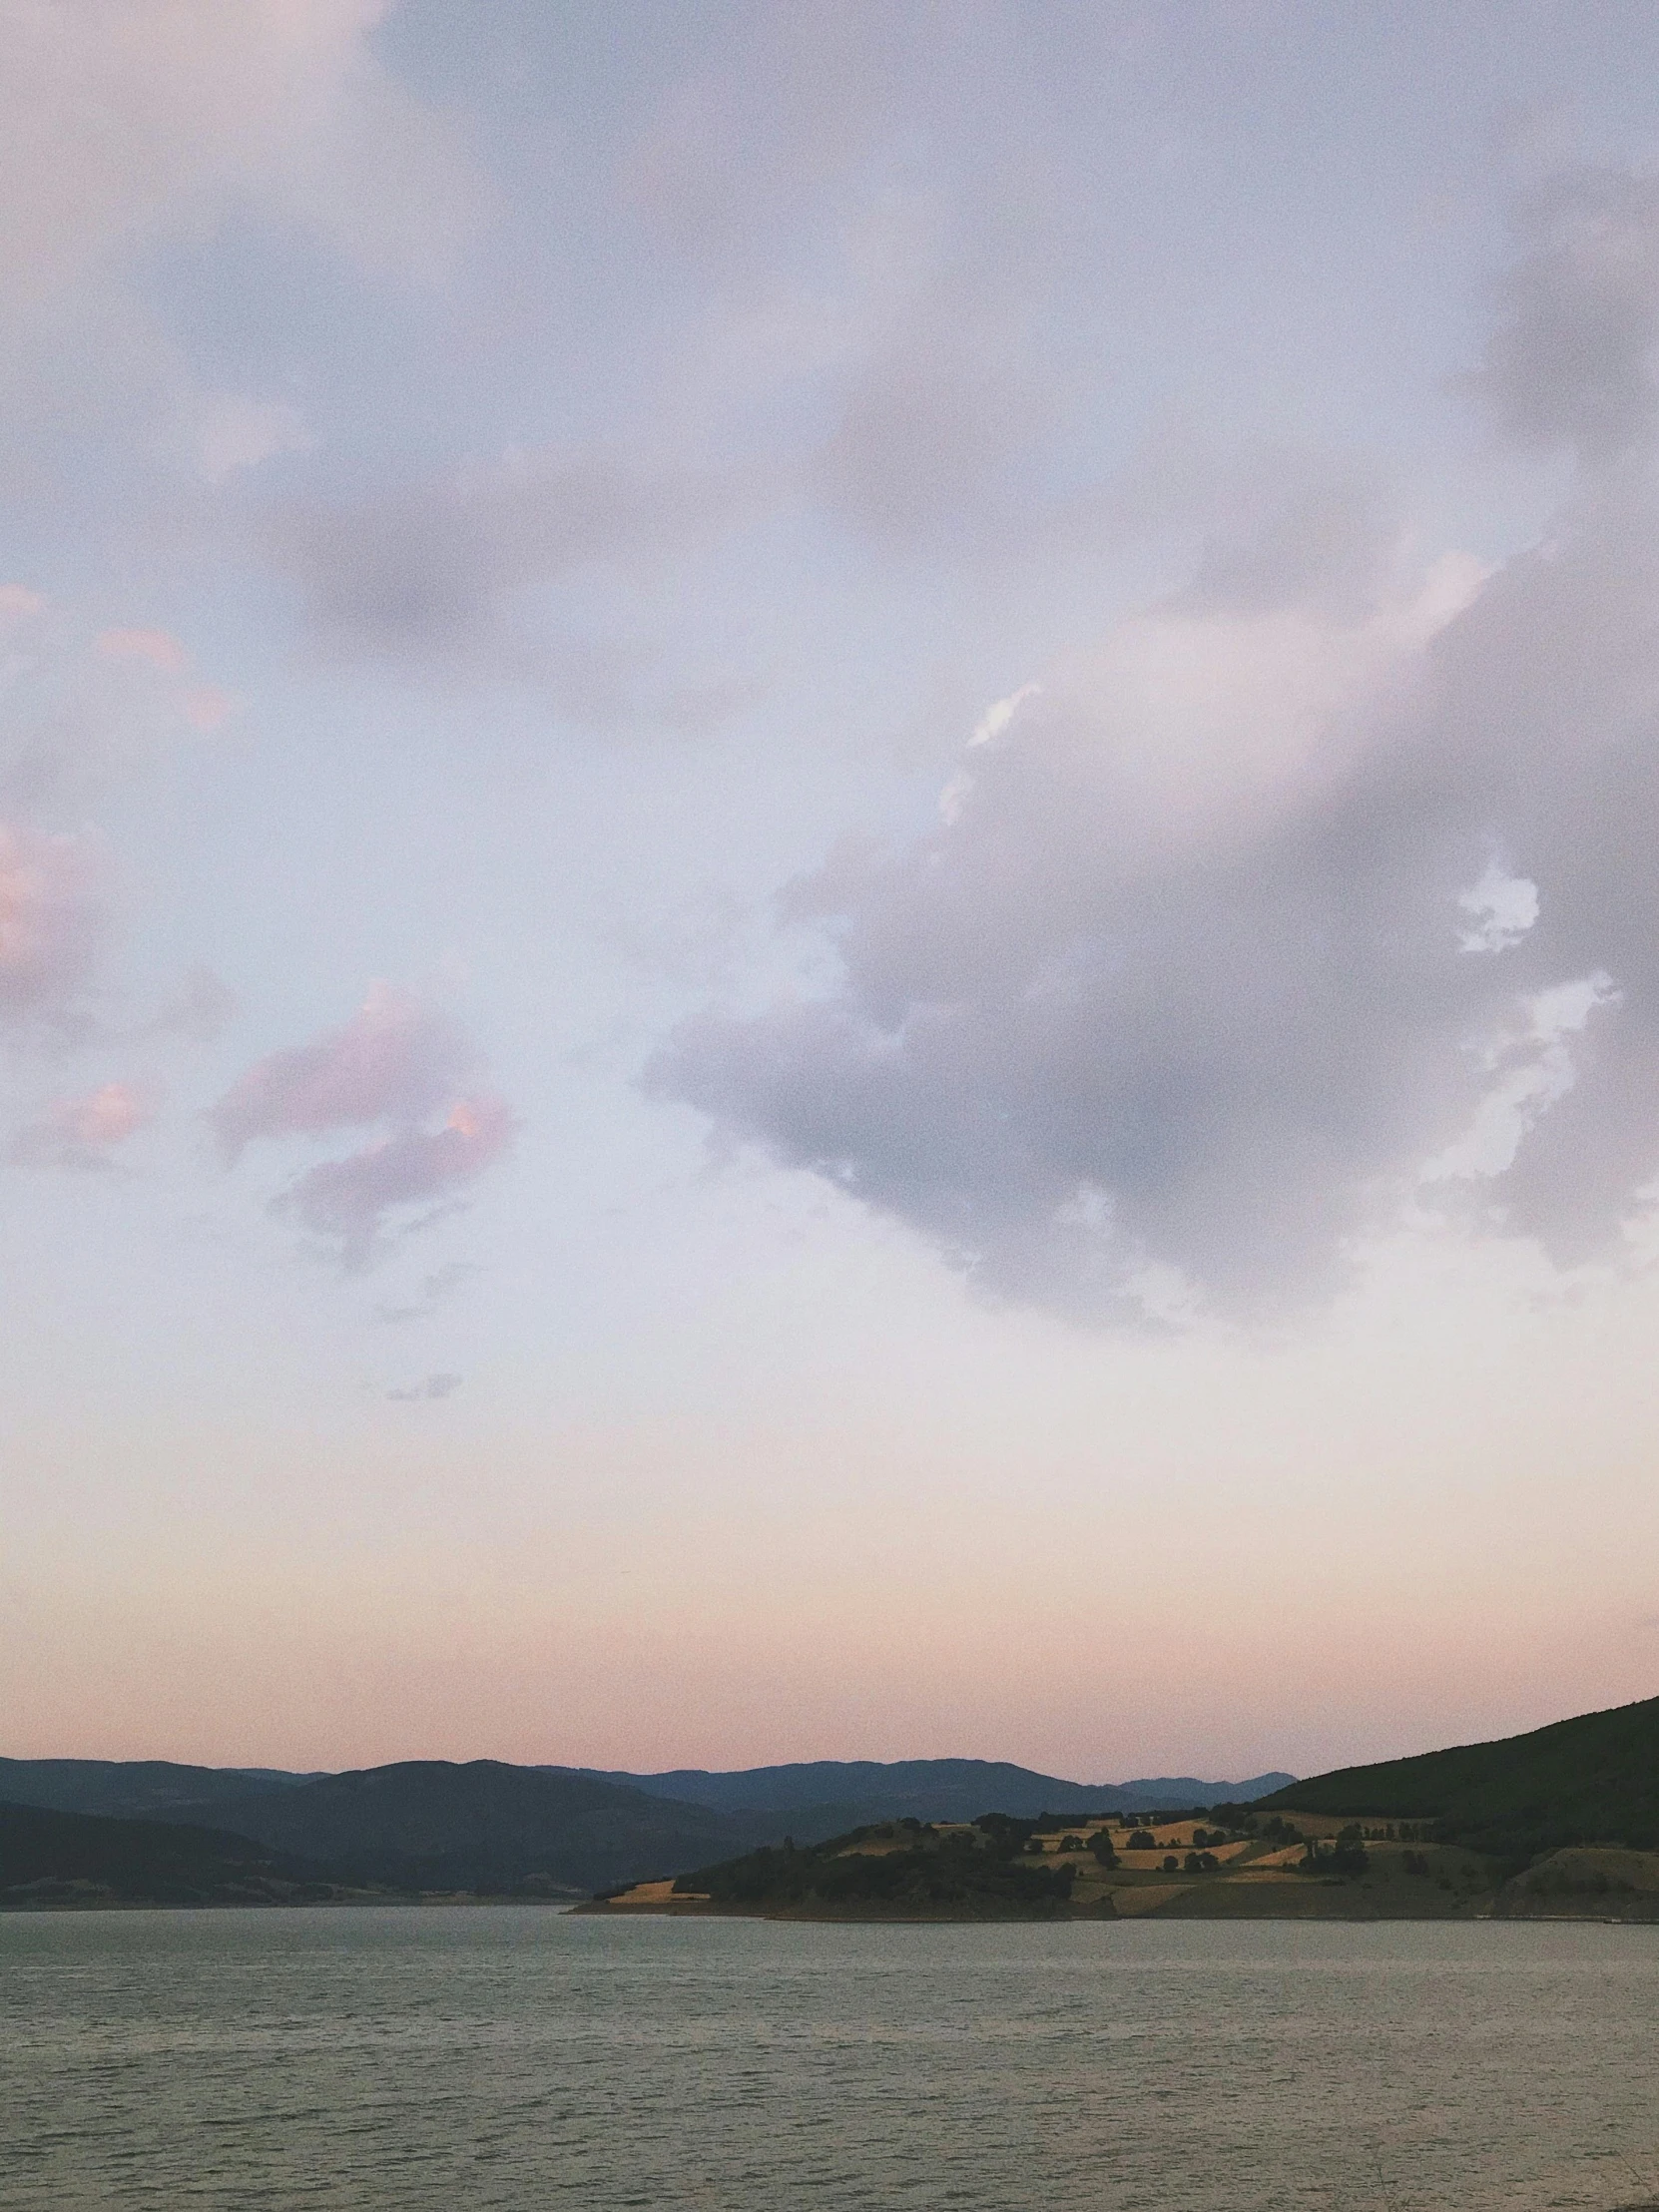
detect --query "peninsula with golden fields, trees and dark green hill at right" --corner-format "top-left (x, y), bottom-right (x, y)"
top-left (582, 1699), bottom-right (1659, 1920)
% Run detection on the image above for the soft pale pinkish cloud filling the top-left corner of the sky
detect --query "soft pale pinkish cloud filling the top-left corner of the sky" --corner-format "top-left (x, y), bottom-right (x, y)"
top-left (0, 0), bottom-right (489, 526)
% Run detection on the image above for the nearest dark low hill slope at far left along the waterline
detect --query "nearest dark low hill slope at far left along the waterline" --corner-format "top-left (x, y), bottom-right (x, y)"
top-left (0, 1803), bottom-right (344, 1907)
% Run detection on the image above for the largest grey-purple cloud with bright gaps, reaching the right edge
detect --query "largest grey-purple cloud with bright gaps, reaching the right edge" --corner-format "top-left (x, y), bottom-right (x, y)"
top-left (646, 391), bottom-right (1659, 1317)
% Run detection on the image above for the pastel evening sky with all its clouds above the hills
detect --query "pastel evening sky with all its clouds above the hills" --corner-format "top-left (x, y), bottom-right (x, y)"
top-left (0, 0), bottom-right (1659, 1781)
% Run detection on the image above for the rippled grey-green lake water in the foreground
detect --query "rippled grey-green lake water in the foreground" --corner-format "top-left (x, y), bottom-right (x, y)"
top-left (0, 1909), bottom-right (1659, 2212)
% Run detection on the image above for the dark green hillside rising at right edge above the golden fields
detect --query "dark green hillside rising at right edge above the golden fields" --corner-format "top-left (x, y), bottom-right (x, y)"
top-left (1257, 1697), bottom-right (1659, 1861)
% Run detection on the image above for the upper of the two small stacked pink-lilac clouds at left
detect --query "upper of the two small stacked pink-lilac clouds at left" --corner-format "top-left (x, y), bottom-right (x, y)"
top-left (211, 982), bottom-right (478, 1164)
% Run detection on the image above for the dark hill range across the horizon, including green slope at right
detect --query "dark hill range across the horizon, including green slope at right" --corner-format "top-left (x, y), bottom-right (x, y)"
top-left (0, 1699), bottom-right (1659, 1905)
